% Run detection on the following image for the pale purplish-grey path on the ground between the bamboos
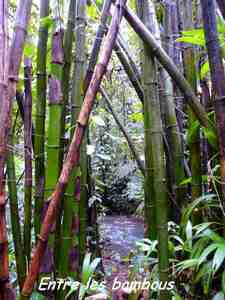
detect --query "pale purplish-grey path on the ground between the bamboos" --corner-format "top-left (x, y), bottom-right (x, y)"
top-left (98, 215), bottom-right (144, 288)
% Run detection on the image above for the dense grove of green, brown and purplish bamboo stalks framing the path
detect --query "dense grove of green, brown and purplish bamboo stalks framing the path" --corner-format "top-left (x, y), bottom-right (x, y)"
top-left (0, 0), bottom-right (225, 300)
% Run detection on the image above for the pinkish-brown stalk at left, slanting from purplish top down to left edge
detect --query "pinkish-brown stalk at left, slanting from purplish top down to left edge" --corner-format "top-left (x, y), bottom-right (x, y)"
top-left (0, 0), bottom-right (32, 299)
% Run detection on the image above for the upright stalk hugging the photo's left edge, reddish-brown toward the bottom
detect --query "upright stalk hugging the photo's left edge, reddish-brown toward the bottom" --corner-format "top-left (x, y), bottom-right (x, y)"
top-left (0, 0), bottom-right (10, 300)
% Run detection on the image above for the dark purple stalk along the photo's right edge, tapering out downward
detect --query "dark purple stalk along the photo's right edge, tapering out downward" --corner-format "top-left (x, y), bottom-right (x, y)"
top-left (201, 0), bottom-right (225, 233)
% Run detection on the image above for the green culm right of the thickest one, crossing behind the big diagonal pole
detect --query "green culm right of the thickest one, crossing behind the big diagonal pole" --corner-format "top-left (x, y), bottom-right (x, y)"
top-left (161, 3), bottom-right (186, 221)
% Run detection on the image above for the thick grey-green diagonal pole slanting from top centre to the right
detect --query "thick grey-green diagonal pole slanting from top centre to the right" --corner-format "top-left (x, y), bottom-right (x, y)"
top-left (124, 7), bottom-right (209, 127)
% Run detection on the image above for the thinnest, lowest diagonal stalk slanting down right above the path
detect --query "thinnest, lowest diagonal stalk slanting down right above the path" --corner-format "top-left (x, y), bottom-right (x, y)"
top-left (100, 87), bottom-right (145, 176)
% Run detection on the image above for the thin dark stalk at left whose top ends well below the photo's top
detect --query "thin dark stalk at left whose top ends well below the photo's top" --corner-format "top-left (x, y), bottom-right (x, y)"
top-left (23, 58), bottom-right (32, 262)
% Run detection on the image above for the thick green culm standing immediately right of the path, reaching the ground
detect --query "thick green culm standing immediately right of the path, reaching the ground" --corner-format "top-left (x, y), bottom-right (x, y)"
top-left (137, 0), bottom-right (170, 300)
